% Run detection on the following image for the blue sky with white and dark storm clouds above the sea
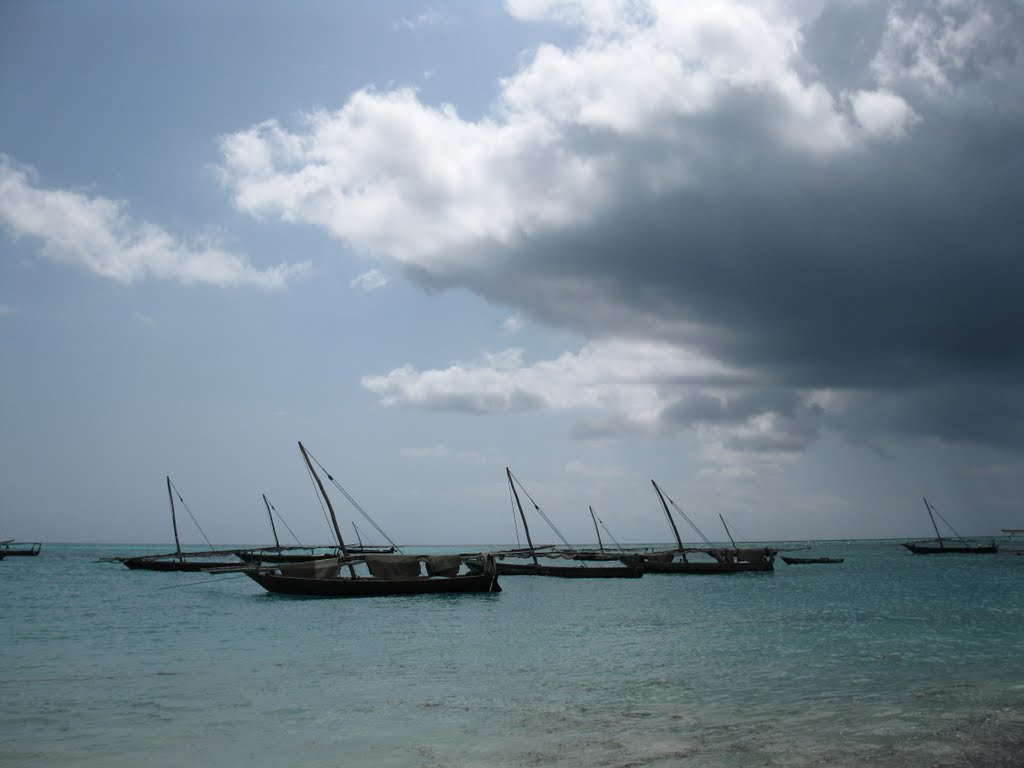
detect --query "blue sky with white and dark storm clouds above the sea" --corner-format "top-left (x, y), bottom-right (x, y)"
top-left (0, 0), bottom-right (1024, 546)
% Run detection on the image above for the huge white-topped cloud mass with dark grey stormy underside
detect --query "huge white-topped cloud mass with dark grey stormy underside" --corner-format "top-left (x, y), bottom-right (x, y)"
top-left (221, 0), bottom-right (1024, 455)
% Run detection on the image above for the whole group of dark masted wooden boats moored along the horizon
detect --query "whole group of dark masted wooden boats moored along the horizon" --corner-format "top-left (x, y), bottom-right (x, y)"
top-left (90, 442), bottom-right (1015, 597)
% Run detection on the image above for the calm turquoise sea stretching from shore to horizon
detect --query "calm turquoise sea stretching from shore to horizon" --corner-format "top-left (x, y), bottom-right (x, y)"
top-left (0, 541), bottom-right (1024, 768)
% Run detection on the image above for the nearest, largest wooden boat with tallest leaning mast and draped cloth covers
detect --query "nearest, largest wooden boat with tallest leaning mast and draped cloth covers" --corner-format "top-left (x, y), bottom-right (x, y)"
top-left (236, 441), bottom-right (501, 597)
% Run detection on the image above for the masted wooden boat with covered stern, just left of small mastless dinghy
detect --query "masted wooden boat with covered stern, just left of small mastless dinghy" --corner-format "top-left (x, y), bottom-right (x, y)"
top-left (643, 480), bottom-right (775, 575)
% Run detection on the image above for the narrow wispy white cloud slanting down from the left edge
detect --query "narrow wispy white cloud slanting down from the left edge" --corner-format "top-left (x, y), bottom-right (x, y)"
top-left (0, 155), bottom-right (309, 289)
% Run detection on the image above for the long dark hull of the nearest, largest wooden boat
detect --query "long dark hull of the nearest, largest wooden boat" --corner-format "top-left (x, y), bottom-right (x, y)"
top-left (246, 571), bottom-right (502, 597)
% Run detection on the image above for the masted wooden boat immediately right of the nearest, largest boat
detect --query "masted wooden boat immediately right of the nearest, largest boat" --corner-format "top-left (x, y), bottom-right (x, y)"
top-left (464, 467), bottom-right (644, 579)
